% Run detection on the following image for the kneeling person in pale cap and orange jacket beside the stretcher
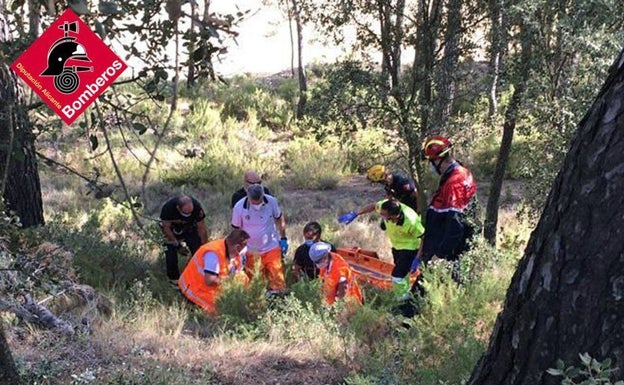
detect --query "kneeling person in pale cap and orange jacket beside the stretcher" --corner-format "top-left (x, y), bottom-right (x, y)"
top-left (309, 242), bottom-right (363, 305)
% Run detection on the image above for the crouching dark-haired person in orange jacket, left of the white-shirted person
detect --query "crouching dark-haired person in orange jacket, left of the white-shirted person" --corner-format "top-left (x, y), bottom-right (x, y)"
top-left (178, 229), bottom-right (249, 314)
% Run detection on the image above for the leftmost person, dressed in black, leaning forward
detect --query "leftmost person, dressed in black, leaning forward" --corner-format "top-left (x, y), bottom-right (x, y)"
top-left (160, 195), bottom-right (208, 284)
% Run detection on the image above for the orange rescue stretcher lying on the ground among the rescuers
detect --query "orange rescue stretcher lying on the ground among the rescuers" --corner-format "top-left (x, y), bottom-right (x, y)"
top-left (336, 247), bottom-right (420, 290)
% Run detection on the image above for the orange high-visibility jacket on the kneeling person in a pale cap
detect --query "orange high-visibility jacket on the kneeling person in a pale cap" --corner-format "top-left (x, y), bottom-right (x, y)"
top-left (319, 252), bottom-right (362, 305)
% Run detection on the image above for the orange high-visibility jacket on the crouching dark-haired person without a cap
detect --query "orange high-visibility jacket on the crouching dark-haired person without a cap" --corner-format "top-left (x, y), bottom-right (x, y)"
top-left (178, 238), bottom-right (244, 313)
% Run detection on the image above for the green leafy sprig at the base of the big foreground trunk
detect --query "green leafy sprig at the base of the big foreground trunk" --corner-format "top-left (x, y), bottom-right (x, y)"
top-left (546, 353), bottom-right (624, 385)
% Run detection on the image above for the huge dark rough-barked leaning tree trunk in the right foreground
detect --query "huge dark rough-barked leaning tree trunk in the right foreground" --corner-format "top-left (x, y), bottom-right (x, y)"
top-left (469, 47), bottom-right (624, 385)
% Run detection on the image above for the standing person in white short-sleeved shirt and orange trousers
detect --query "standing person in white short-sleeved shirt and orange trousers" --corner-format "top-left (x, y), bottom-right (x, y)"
top-left (232, 184), bottom-right (288, 294)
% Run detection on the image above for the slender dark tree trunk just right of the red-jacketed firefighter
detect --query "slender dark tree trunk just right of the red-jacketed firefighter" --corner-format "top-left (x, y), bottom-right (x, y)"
top-left (483, 27), bottom-right (531, 245)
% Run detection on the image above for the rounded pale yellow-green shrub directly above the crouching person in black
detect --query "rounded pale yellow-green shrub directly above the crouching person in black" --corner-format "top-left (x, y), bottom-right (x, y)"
top-left (284, 137), bottom-right (346, 190)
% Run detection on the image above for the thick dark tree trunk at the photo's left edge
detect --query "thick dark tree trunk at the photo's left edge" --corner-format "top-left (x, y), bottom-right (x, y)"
top-left (0, 2), bottom-right (43, 227)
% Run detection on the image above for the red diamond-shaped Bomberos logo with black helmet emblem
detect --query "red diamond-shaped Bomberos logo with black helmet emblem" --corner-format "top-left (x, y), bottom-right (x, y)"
top-left (11, 9), bottom-right (127, 124)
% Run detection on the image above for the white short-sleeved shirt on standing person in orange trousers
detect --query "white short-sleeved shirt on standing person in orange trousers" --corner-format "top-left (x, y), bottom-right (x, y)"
top-left (232, 194), bottom-right (282, 253)
